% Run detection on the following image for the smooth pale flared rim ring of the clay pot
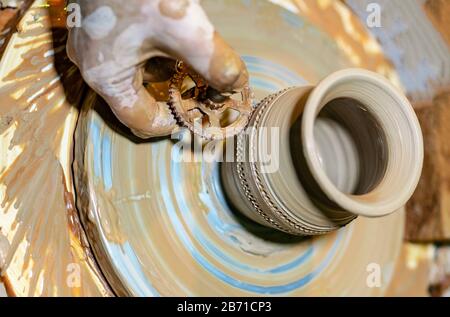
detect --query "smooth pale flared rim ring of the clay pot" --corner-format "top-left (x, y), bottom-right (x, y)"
top-left (302, 68), bottom-right (424, 217)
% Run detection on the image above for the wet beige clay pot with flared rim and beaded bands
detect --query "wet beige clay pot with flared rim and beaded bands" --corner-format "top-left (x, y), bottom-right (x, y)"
top-left (222, 69), bottom-right (423, 235)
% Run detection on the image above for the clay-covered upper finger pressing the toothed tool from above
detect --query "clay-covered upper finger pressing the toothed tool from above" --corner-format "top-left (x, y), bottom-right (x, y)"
top-left (155, 0), bottom-right (248, 91)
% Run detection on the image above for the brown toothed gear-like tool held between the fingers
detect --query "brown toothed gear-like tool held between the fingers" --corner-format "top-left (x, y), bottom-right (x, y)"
top-left (169, 62), bottom-right (253, 140)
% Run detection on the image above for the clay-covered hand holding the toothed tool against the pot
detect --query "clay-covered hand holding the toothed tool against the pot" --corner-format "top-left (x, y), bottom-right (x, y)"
top-left (67, 0), bottom-right (248, 138)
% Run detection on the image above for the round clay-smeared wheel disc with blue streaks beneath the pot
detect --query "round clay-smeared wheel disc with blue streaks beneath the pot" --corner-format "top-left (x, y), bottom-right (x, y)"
top-left (75, 1), bottom-right (403, 296)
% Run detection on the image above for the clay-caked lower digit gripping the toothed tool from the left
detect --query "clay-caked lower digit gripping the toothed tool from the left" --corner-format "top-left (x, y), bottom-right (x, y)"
top-left (67, 1), bottom-right (177, 138)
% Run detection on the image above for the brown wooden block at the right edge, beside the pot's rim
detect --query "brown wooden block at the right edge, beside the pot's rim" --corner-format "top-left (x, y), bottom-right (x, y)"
top-left (406, 89), bottom-right (450, 241)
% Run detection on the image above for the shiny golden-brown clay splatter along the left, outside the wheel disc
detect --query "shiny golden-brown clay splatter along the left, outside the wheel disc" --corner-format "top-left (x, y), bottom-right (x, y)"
top-left (0, 1), bottom-right (112, 296)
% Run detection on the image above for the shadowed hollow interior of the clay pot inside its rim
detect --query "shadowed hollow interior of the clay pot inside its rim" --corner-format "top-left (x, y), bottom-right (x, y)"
top-left (314, 98), bottom-right (388, 195)
